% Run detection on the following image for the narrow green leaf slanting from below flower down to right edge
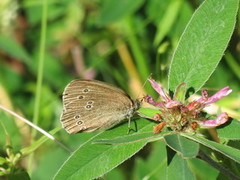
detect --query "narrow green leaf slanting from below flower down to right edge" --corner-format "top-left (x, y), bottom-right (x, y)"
top-left (182, 134), bottom-right (240, 163)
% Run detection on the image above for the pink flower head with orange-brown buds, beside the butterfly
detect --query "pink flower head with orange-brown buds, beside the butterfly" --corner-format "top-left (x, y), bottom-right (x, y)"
top-left (144, 78), bottom-right (232, 133)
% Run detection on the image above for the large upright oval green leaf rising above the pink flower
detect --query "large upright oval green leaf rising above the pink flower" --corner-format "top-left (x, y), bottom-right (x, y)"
top-left (168, 0), bottom-right (239, 92)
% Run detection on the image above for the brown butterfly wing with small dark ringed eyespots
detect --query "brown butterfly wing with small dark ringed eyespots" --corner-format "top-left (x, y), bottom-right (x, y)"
top-left (61, 80), bottom-right (135, 134)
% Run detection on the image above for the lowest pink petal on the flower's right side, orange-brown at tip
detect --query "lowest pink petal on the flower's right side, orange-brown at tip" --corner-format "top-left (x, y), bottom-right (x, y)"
top-left (197, 112), bottom-right (229, 128)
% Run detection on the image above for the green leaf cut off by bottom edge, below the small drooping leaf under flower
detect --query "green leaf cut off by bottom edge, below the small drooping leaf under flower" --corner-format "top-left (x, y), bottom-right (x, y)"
top-left (166, 154), bottom-right (196, 180)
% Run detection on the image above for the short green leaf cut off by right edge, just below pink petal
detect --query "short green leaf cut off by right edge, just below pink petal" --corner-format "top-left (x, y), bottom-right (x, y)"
top-left (217, 119), bottom-right (240, 140)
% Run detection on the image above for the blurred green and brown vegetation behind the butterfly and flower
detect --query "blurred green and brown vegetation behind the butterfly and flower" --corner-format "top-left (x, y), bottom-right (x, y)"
top-left (0, 0), bottom-right (240, 179)
